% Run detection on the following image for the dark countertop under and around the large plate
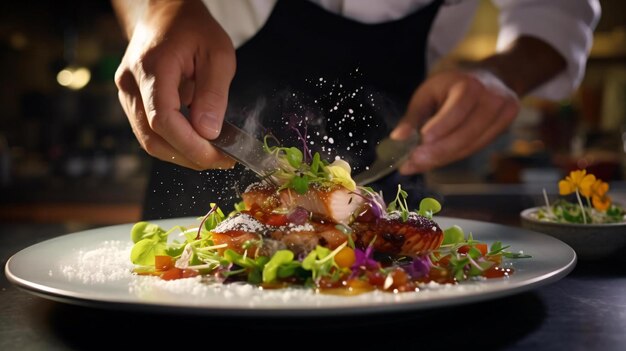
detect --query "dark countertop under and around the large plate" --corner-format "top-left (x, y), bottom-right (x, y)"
top-left (0, 191), bottom-right (626, 350)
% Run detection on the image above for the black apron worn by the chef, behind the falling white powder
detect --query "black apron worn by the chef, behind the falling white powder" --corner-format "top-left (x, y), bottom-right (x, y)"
top-left (143, 0), bottom-right (441, 219)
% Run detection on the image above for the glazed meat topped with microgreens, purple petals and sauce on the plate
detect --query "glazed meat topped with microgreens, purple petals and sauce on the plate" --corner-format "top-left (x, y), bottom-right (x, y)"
top-left (131, 143), bottom-right (530, 295)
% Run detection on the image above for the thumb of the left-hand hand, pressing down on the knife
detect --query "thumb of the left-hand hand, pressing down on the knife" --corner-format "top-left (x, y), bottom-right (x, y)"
top-left (190, 55), bottom-right (235, 139)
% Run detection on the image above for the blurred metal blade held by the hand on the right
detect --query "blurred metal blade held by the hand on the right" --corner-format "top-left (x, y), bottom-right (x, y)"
top-left (352, 133), bottom-right (421, 185)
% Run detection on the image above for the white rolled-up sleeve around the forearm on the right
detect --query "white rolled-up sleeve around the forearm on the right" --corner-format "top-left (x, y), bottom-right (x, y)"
top-left (492, 0), bottom-right (601, 100)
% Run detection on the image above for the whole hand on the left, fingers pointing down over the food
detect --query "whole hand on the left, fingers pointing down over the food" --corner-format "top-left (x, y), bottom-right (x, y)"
top-left (115, 0), bottom-right (236, 170)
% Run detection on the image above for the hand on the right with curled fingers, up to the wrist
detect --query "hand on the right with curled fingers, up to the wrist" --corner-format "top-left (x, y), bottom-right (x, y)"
top-left (391, 71), bottom-right (520, 174)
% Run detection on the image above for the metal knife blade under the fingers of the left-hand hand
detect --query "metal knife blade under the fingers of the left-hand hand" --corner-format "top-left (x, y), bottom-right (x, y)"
top-left (209, 120), bottom-right (278, 177)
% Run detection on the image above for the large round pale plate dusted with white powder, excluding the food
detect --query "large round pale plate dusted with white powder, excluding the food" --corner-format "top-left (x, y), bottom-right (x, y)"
top-left (5, 217), bottom-right (576, 316)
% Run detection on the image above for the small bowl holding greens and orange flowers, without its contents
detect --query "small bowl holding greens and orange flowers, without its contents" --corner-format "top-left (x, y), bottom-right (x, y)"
top-left (520, 207), bottom-right (626, 261)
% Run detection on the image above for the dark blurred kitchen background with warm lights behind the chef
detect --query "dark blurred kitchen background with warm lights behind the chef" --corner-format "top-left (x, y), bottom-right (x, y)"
top-left (0, 0), bottom-right (626, 226)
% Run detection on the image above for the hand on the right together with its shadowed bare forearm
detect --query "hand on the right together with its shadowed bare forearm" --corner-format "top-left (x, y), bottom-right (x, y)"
top-left (391, 36), bottom-right (567, 174)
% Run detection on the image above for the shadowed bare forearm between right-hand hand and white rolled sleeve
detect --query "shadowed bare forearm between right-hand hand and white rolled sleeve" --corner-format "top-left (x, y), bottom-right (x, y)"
top-left (468, 36), bottom-right (567, 97)
